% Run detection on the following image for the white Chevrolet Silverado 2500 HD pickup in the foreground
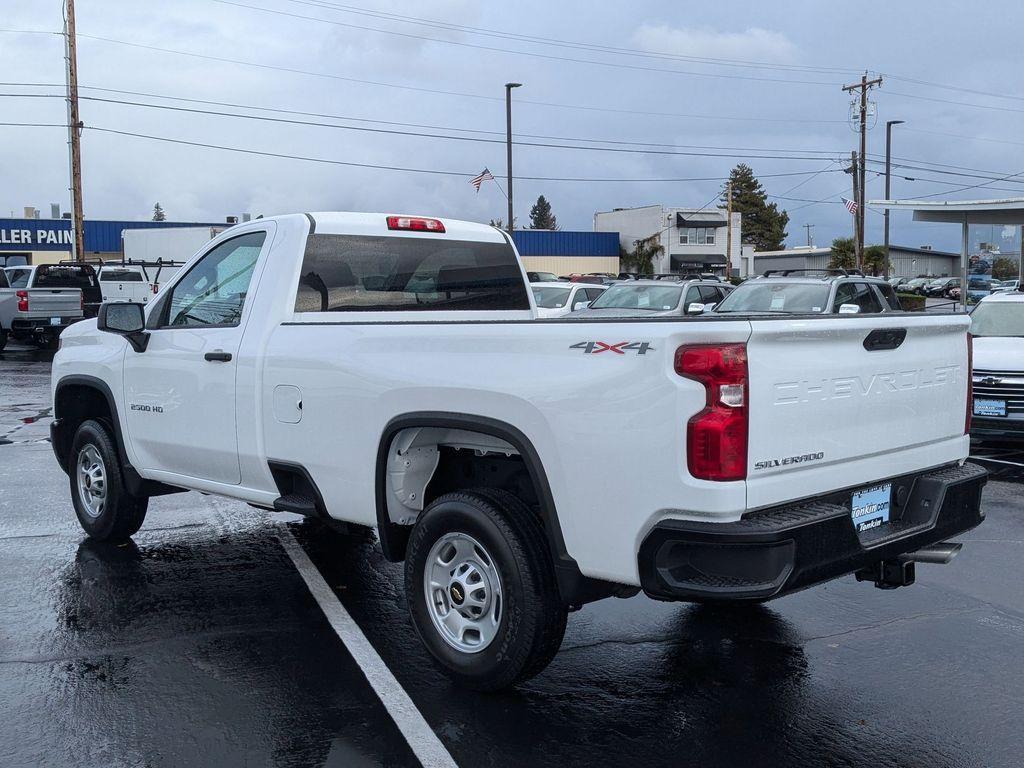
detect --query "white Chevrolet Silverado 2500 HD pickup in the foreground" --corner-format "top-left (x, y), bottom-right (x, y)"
top-left (51, 213), bottom-right (986, 689)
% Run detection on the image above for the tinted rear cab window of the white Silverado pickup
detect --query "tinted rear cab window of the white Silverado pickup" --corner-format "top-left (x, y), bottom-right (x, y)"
top-left (295, 233), bottom-right (530, 312)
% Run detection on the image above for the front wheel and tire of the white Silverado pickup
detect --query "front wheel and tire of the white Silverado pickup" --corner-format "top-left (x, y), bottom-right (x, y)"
top-left (68, 420), bottom-right (150, 542)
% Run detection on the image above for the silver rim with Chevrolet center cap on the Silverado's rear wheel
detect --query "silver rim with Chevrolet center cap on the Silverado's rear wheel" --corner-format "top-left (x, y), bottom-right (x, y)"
top-left (423, 532), bottom-right (504, 653)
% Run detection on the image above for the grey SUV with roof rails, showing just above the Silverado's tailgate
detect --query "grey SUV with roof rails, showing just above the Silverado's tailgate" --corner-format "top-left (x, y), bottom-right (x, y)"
top-left (715, 269), bottom-right (902, 314)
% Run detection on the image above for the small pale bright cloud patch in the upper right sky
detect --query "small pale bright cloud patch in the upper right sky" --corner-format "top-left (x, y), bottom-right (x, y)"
top-left (633, 24), bottom-right (797, 62)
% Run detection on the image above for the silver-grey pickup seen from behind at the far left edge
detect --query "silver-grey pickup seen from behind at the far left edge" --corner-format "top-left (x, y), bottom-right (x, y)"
top-left (0, 266), bottom-right (84, 349)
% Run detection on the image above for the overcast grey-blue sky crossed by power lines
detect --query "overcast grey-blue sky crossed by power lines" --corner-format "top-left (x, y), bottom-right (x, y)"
top-left (0, 0), bottom-right (1024, 249)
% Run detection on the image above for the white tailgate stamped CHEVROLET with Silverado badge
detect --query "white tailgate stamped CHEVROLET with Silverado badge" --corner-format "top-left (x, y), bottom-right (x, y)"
top-left (746, 313), bottom-right (970, 509)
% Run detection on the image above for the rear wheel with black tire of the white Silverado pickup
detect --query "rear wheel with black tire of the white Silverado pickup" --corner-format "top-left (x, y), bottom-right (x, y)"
top-left (406, 489), bottom-right (567, 690)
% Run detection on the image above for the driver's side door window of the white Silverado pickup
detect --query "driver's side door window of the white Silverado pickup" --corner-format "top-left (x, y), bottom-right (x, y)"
top-left (161, 232), bottom-right (266, 328)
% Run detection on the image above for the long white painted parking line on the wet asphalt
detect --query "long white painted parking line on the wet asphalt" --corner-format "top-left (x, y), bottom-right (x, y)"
top-left (280, 525), bottom-right (457, 768)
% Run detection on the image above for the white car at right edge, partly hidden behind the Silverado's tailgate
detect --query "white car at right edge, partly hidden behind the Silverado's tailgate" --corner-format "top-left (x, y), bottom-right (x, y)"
top-left (971, 292), bottom-right (1024, 439)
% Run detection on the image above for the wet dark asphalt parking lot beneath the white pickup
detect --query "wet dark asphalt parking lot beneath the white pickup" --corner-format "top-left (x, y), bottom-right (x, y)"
top-left (0, 344), bottom-right (1024, 768)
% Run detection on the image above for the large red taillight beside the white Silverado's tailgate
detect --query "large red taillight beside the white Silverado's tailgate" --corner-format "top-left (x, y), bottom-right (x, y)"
top-left (676, 344), bottom-right (749, 480)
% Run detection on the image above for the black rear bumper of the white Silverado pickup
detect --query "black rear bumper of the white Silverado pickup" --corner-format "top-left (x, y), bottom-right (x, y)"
top-left (639, 464), bottom-right (988, 602)
